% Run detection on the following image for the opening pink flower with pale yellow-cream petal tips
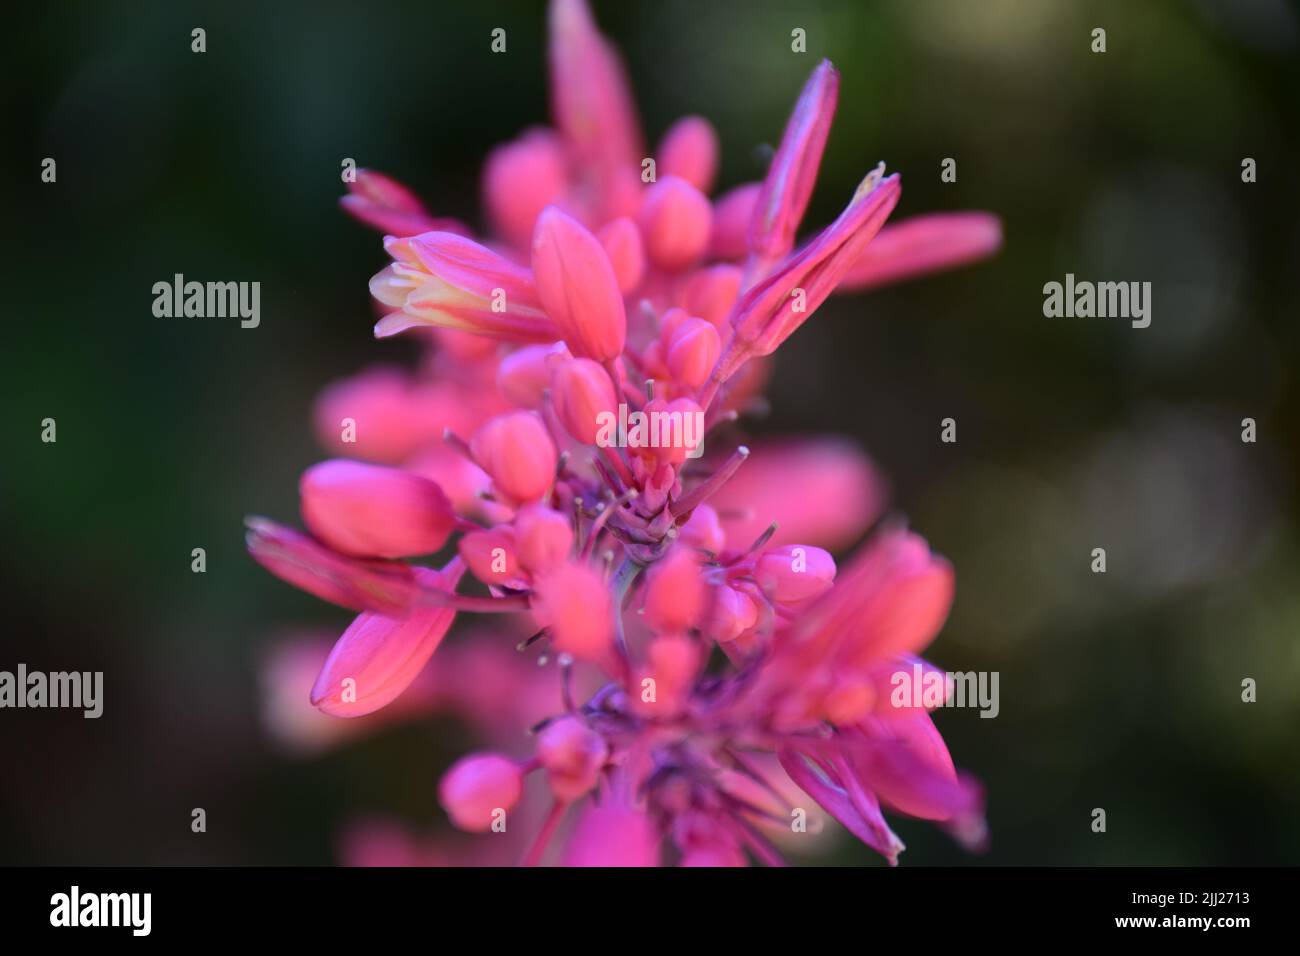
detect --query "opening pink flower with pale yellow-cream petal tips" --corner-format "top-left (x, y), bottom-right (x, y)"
top-left (371, 233), bottom-right (559, 342)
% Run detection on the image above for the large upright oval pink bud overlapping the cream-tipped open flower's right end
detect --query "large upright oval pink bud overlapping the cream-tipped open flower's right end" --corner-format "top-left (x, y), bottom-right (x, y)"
top-left (533, 206), bottom-right (628, 362)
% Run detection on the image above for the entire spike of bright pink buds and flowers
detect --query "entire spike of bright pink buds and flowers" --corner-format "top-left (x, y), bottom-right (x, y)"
top-left (248, 0), bottom-right (1001, 865)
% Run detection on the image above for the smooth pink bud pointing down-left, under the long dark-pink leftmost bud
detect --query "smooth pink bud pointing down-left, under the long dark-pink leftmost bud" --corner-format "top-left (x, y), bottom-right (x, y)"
top-left (311, 566), bottom-right (463, 717)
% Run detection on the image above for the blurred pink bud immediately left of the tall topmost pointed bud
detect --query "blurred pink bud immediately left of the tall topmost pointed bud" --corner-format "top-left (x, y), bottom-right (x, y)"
top-left (484, 129), bottom-right (568, 247)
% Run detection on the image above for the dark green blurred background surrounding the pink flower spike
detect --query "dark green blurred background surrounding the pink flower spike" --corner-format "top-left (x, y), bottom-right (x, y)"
top-left (0, 0), bottom-right (1300, 865)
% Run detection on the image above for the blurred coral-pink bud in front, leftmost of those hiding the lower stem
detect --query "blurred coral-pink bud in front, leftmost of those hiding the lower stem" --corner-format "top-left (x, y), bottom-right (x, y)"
top-left (533, 562), bottom-right (614, 662)
